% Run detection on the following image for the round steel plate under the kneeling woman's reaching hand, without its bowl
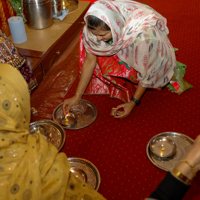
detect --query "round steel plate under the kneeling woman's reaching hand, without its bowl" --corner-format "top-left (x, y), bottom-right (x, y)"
top-left (53, 99), bottom-right (98, 130)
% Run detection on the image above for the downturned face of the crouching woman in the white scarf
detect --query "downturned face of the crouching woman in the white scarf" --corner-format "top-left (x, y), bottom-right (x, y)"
top-left (90, 28), bottom-right (112, 42)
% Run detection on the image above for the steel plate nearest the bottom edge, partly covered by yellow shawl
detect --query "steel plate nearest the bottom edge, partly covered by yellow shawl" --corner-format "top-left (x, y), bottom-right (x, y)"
top-left (68, 158), bottom-right (101, 191)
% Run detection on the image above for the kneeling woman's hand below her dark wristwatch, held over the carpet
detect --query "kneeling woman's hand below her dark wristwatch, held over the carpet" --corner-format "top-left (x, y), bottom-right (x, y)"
top-left (114, 101), bottom-right (136, 119)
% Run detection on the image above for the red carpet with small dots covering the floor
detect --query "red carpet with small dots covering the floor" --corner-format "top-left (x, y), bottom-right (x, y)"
top-left (31, 0), bottom-right (200, 200)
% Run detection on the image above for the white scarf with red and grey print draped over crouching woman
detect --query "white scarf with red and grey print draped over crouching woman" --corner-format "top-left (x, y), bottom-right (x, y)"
top-left (83, 1), bottom-right (176, 88)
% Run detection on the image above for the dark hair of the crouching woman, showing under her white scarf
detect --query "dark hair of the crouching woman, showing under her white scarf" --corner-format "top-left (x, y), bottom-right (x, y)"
top-left (86, 15), bottom-right (110, 31)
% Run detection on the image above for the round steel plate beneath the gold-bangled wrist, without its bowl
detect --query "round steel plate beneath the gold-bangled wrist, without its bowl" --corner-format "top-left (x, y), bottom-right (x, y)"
top-left (146, 132), bottom-right (194, 171)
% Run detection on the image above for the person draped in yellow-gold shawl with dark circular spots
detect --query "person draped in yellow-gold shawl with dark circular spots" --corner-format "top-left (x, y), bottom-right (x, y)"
top-left (0, 64), bottom-right (105, 200)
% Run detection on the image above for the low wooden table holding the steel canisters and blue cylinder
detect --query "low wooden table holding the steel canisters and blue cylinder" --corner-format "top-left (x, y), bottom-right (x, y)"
top-left (9, 1), bottom-right (90, 86)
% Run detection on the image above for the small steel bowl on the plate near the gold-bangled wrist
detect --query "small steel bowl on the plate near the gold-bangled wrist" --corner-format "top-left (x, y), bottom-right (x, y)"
top-left (150, 137), bottom-right (176, 158)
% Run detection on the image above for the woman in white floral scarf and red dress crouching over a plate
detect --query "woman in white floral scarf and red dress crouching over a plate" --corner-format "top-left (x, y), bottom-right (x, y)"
top-left (63, 1), bottom-right (176, 118)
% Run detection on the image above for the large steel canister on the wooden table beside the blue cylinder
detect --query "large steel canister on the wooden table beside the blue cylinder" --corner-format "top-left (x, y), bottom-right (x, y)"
top-left (23, 0), bottom-right (53, 29)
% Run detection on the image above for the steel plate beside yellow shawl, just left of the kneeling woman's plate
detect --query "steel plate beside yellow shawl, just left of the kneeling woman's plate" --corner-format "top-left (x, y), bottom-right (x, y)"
top-left (29, 120), bottom-right (66, 151)
